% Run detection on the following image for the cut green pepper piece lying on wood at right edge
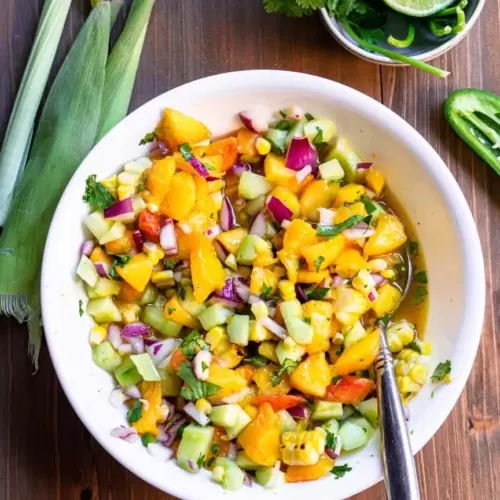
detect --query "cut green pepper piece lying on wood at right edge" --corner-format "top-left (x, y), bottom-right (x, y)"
top-left (444, 89), bottom-right (500, 175)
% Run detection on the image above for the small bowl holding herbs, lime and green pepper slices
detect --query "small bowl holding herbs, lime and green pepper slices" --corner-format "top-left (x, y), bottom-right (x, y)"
top-left (321, 0), bottom-right (486, 66)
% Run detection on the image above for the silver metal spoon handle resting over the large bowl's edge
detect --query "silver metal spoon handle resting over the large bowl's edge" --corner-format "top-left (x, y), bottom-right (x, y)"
top-left (375, 325), bottom-right (420, 500)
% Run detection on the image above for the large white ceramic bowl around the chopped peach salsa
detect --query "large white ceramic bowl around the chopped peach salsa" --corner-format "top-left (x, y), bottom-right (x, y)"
top-left (42, 71), bottom-right (485, 500)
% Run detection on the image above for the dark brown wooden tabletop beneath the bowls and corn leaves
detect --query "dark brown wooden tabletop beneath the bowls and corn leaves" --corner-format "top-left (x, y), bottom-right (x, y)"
top-left (0, 0), bottom-right (500, 500)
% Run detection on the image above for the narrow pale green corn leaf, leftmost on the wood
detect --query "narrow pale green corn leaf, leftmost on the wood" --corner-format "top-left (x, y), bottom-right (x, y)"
top-left (0, 0), bottom-right (71, 226)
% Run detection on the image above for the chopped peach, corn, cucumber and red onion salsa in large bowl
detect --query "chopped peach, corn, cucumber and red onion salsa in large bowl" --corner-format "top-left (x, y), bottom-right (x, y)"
top-left (77, 106), bottom-right (430, 490)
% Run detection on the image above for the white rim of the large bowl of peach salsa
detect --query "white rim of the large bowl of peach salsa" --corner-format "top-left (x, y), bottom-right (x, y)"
top-left (41, 70), bottom-right (486, 500)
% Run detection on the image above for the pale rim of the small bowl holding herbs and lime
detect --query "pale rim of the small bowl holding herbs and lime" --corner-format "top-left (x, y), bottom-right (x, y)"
top-left (320, 0), bottom-right (486, 67)
